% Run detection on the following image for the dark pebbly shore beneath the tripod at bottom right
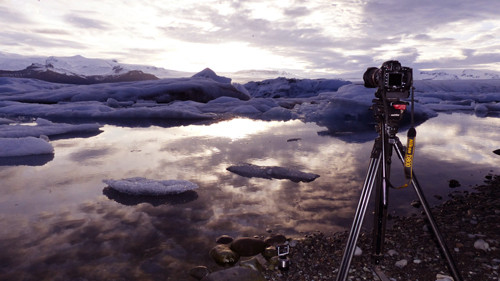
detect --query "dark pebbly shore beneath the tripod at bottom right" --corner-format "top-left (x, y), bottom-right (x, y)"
top-left (265, 175), bottom-right (500, 281)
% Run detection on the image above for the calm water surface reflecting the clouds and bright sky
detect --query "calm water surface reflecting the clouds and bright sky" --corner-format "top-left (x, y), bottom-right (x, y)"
top-left (0, 114), bottom-right (500, 280)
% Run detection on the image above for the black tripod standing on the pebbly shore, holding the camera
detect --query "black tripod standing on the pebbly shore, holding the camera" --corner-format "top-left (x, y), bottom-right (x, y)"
top-left (336, 99), bottom-right (463, 281)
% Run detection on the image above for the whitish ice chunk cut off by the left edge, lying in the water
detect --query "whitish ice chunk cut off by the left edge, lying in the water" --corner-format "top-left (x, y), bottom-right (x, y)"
top-left (0, 137), bottom-right (54, 157)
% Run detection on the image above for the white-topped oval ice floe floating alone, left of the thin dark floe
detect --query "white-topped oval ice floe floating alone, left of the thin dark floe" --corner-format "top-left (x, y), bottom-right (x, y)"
top-left (103, 177), bottom-right (198, 196)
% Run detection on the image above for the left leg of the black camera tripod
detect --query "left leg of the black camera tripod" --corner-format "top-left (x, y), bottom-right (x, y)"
top-left (336, 153), bottom-right (382, 281)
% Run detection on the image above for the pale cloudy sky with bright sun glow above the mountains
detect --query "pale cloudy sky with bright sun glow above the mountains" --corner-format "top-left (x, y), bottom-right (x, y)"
top-left (0, 0), bottom-right (500, 74)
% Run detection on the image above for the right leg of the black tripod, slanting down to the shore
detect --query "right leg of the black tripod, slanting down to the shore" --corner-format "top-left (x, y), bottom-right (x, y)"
top-left (396, 139), bottom-right (463, 281)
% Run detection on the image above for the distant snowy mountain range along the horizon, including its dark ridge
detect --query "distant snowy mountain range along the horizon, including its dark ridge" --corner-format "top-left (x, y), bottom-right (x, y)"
top-left (0, 52), bottom-right (500, 84)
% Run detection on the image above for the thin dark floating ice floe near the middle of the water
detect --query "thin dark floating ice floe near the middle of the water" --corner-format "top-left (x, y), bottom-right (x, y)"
top-left (227, 163), bottom-right (319, 182)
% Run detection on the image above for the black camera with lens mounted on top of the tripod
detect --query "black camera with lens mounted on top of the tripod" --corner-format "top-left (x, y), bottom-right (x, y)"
top-left (363, 60), bottom-right (413, 101)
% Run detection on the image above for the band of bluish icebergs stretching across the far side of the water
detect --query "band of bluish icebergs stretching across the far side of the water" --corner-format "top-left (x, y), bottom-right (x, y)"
top-left (0, 66), bottom-right (500, 136)
